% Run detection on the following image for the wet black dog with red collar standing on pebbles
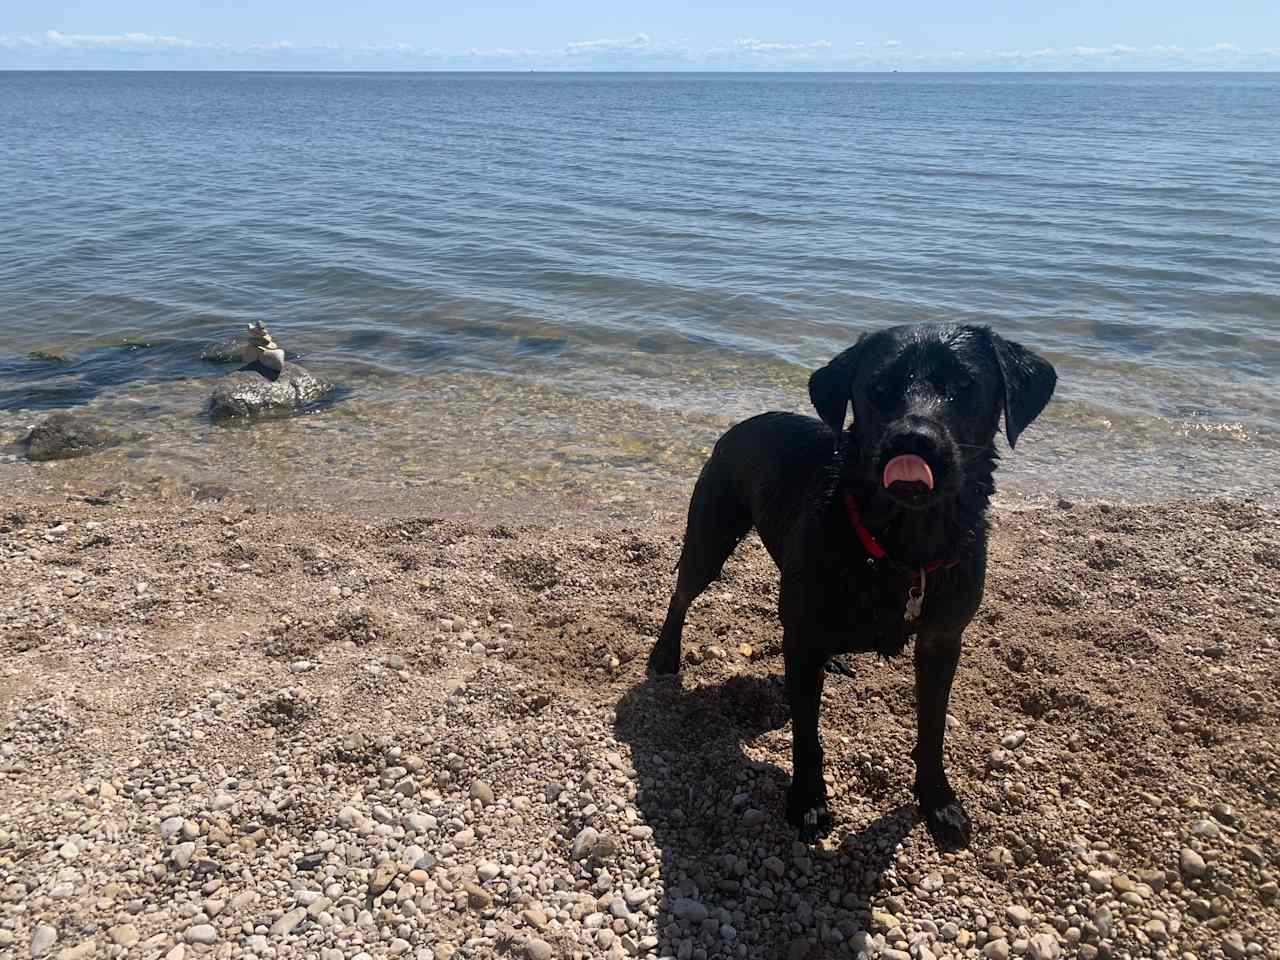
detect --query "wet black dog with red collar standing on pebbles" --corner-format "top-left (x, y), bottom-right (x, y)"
top-left (649, 325), bottom-right (1057, 847)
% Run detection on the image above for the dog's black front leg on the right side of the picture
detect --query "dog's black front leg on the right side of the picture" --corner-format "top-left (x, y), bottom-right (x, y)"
top-left (914, 632), bottom-right (970, 849)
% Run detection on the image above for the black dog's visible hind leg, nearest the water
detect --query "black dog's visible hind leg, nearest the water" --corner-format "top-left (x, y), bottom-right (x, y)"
top-left (649, 456), bottom-right (751, 673)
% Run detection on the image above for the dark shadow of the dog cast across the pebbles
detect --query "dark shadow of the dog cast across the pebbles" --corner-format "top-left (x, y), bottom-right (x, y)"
top-left (614, 676), bottom-right (915, 960)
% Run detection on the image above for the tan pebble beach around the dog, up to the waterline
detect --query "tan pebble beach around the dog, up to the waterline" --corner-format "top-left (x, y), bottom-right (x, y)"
top-left (0, 465), bottom-right (1280, 960)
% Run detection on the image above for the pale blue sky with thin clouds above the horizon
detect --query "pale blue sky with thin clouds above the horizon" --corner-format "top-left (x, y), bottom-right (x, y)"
top-left (0, 0), bottom-right (1280, 70)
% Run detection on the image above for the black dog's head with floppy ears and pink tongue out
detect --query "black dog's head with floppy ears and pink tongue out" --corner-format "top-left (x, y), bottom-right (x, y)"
top-left (809, 324), bottom-right (1057, 507)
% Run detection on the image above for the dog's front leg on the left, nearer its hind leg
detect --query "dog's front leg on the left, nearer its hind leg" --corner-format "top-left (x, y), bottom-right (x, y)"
top-left (782, 628), bottom-right (831, 844)
